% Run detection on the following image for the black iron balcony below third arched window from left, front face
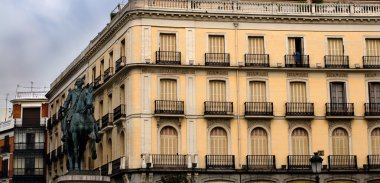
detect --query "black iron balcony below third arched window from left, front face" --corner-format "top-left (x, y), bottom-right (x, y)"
top-left (247, 155), bottom-right (276, 171)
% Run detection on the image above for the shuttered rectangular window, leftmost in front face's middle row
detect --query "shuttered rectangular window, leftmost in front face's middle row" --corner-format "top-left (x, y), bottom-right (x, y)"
top-left (160, 79), bottom-right (177, 101)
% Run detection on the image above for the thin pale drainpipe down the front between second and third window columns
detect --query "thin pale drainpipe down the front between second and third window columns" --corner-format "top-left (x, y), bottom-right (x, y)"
top-left (234, 22), bottom-right (241, 168)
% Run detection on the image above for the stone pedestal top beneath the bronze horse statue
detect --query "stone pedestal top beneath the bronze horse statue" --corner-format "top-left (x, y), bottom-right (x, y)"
top-left (56, 170), bottom-right (111, 183)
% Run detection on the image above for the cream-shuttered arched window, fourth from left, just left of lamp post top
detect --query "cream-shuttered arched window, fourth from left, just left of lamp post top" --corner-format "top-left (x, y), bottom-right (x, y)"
top-left (292, 128), bottom-right (310, 155)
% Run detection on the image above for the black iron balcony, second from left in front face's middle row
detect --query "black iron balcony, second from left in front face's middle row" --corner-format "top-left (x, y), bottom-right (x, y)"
top-left (204, 101), bottom-right (233, 117)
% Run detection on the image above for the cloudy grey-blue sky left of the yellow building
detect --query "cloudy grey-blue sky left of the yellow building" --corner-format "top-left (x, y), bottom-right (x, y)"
top-left (0, 0), bottom-right (121, 116)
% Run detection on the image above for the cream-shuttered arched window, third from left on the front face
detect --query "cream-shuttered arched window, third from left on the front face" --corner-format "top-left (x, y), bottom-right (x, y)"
top-left (251, 128), bottom-right (268, 155)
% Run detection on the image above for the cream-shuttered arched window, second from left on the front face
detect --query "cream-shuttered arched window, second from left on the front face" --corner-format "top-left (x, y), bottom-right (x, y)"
top-left (210, 127), bottom-right (228, 155)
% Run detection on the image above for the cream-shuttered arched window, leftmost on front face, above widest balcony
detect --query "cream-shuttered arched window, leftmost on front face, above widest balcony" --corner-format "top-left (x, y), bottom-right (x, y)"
top-left (160, 126), bottom-right (178, 154)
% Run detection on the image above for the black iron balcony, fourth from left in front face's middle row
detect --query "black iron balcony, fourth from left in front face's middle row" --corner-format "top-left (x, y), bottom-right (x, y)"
top-left (285, 102), bottom-right (314, 117)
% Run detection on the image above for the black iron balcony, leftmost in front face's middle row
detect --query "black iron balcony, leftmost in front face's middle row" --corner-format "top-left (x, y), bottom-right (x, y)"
top-left (154, 100), bottom-right (184, 115)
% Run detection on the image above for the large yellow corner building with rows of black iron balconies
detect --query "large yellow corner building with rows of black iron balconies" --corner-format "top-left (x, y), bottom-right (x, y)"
top-left (46, 0), bottom-right (380, 183)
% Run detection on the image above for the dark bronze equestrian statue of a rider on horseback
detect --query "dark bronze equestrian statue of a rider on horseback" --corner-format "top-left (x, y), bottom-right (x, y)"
top-left (61, 78), bottom-right (100, 170)
